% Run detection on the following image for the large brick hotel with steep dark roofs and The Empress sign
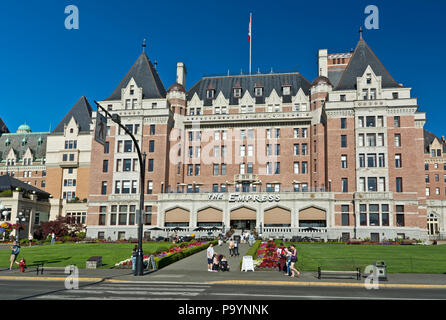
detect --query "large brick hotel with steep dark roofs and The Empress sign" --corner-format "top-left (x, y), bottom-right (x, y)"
top-left (83, 39), bottom-right (446, 241)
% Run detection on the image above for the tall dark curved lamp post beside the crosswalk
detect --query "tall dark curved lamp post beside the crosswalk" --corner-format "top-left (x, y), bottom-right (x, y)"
top-left (95, 101), bottom-right (146, 276)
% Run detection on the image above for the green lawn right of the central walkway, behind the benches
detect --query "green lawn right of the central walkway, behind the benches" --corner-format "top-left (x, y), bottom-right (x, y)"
top-left (285, 243), bottom-right (446, 273)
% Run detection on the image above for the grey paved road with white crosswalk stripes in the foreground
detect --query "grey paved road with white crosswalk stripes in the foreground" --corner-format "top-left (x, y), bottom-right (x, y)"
top-left (0, 281), bottom-right (446, 300)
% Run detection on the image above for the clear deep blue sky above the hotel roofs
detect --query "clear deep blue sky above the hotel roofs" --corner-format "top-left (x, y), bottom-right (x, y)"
top-left (0, 0), bottom-right (446, 136)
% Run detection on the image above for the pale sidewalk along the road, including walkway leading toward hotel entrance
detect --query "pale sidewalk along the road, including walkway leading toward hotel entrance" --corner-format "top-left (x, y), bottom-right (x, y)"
top-left (0, 243), bottom-right (446, 289)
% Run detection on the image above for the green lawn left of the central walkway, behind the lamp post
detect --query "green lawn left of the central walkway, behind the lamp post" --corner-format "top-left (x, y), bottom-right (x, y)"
top-left (0, 242), bottom-right (172, 269)
